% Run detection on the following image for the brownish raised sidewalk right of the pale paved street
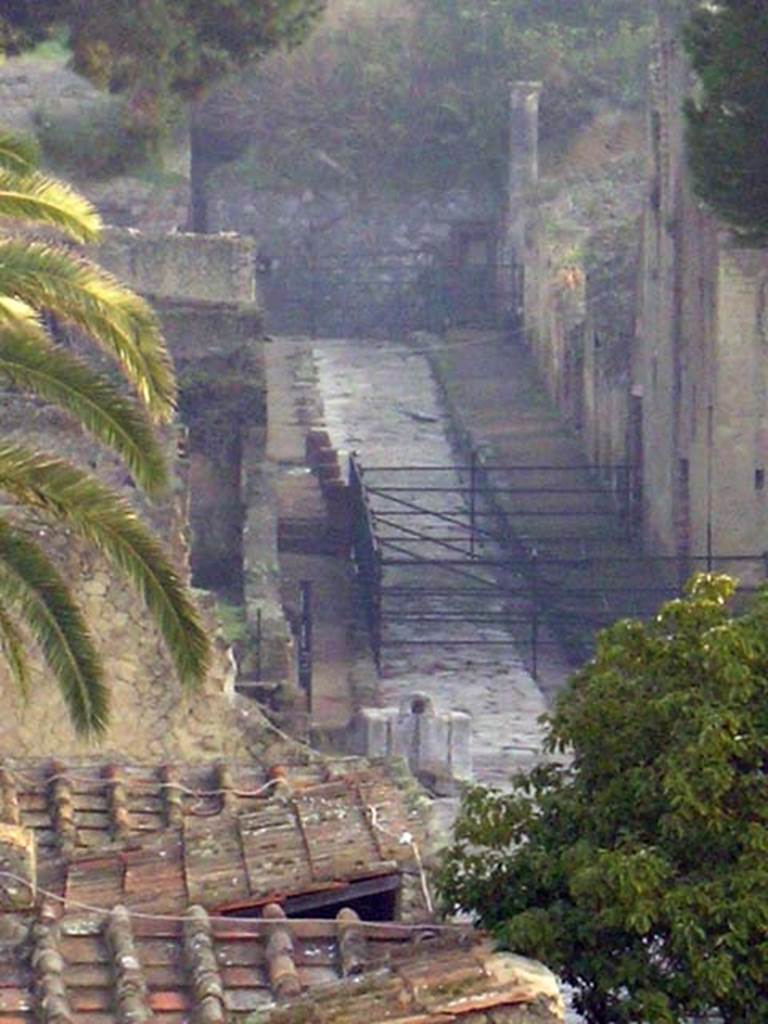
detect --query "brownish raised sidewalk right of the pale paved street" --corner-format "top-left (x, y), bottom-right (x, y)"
top-left (430, 331), bottom-right (674, 689)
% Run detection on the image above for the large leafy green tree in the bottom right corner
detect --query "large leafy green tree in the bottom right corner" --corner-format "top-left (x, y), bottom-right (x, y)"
top-left (439, 575), bottom-right (768, 1024)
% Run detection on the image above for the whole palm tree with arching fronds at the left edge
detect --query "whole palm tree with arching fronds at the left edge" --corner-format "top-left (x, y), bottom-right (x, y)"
top-left (0, 134), bottom-right (210, 735)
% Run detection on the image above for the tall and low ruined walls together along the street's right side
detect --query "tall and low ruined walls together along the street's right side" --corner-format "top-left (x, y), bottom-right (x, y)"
top-left (518, 4), bottom-right (768, 583)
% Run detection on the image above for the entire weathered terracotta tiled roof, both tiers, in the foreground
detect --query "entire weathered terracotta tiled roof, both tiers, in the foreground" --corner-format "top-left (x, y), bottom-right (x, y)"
top-left (0, 759), bottom-right (562, 1024)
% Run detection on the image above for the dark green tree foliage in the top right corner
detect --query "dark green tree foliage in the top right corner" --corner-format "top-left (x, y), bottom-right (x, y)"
top-left (685, 0), bottom-right (768, 244)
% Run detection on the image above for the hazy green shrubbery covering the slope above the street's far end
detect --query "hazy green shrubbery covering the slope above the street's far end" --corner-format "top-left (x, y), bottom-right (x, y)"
top-left (208, 0), bottom-right (650, 190)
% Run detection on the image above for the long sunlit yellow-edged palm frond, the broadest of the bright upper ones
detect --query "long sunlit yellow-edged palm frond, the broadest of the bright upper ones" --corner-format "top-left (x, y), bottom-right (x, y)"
top-left (0, 239), bottom-right (176, 422)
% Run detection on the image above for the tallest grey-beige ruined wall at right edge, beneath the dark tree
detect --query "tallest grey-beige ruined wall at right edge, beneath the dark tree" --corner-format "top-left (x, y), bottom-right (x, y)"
top-left (635, 11), bottom-right (768, 582)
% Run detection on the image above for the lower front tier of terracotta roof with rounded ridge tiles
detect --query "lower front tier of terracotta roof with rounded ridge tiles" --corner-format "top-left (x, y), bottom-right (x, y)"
top-left (0, 904), bottom-right (560, 1024)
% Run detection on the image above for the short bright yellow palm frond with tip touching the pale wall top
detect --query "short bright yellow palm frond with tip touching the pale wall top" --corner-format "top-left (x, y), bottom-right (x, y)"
top-left (0, 166), bottom-right (101, 242)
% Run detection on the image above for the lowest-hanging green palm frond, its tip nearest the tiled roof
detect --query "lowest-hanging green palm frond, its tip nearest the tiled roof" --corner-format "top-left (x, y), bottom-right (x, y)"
top-left (0, 519), bottom-right (109, 735)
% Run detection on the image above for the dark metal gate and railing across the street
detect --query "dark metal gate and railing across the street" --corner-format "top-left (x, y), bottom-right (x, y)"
top-left (350, 454), bottom-right (768, 676)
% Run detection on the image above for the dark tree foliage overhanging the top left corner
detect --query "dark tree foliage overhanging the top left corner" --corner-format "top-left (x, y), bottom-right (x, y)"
top-left (0, 0), bottom-right (325, 132)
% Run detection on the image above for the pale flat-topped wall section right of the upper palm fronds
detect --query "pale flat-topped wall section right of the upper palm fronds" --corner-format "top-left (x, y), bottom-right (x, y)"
top-left (94, 227), bottom-right (257, 305)
